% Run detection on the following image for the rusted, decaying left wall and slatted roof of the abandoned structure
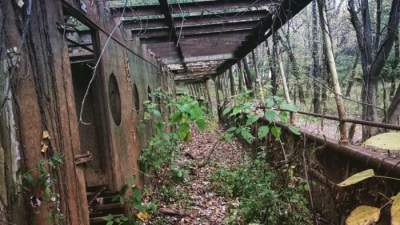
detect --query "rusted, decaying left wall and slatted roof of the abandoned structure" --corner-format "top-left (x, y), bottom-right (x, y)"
top-left (0, 0), bottom-right (330, 225)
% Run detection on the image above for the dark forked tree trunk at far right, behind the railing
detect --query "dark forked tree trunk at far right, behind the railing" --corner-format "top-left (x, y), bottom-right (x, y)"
top-left (348, 0), bottom-right (400, 139)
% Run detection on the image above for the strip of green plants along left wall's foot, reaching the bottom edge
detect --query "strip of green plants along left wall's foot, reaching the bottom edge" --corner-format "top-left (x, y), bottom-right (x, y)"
top-left (100, 90), bottom-right (205, 225)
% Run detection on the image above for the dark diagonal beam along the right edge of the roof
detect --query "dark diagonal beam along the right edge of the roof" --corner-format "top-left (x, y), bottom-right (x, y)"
top-left (217, 0), bottom-right (311, 74)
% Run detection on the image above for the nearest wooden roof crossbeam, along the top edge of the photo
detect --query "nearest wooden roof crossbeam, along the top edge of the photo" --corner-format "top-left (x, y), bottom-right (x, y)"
top-left (110, 0), bottom-right (273, 17)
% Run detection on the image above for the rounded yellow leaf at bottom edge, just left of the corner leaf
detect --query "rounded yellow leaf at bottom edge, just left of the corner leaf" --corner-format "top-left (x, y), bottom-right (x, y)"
top-left (346, 205), bottom-right (381, 225)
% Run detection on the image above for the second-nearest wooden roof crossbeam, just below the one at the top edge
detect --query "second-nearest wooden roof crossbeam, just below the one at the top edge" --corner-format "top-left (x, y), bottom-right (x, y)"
top-left (123, 10), bottom-right (267, 32)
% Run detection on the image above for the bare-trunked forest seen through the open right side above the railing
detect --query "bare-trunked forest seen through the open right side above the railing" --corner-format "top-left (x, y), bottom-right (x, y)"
top-left (206, 0), bottom-right (400, 142)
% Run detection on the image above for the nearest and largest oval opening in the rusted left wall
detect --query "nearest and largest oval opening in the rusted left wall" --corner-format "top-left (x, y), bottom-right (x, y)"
top-left (108, 73), bottom-right (121, 125)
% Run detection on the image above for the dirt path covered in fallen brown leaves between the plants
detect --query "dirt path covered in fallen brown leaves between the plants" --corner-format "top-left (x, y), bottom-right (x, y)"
top-left (148, 128), bottom-right (244, 225)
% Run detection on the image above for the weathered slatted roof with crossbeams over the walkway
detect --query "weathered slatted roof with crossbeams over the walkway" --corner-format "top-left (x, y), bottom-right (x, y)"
top-left (110, 0), bottom-right (311, 81)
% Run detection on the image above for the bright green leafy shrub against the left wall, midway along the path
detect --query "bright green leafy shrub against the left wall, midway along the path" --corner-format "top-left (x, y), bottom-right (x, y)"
top-left (140, 90), bottom-right (206, 174)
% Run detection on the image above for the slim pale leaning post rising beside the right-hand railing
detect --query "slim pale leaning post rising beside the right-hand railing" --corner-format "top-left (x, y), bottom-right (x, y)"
top-left (318, 0), bottom-right (348, 143)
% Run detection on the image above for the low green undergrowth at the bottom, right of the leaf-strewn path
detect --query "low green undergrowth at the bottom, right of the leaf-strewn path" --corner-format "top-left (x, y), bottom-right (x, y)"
top-left (211, 156), bottom-right (312, 225)
